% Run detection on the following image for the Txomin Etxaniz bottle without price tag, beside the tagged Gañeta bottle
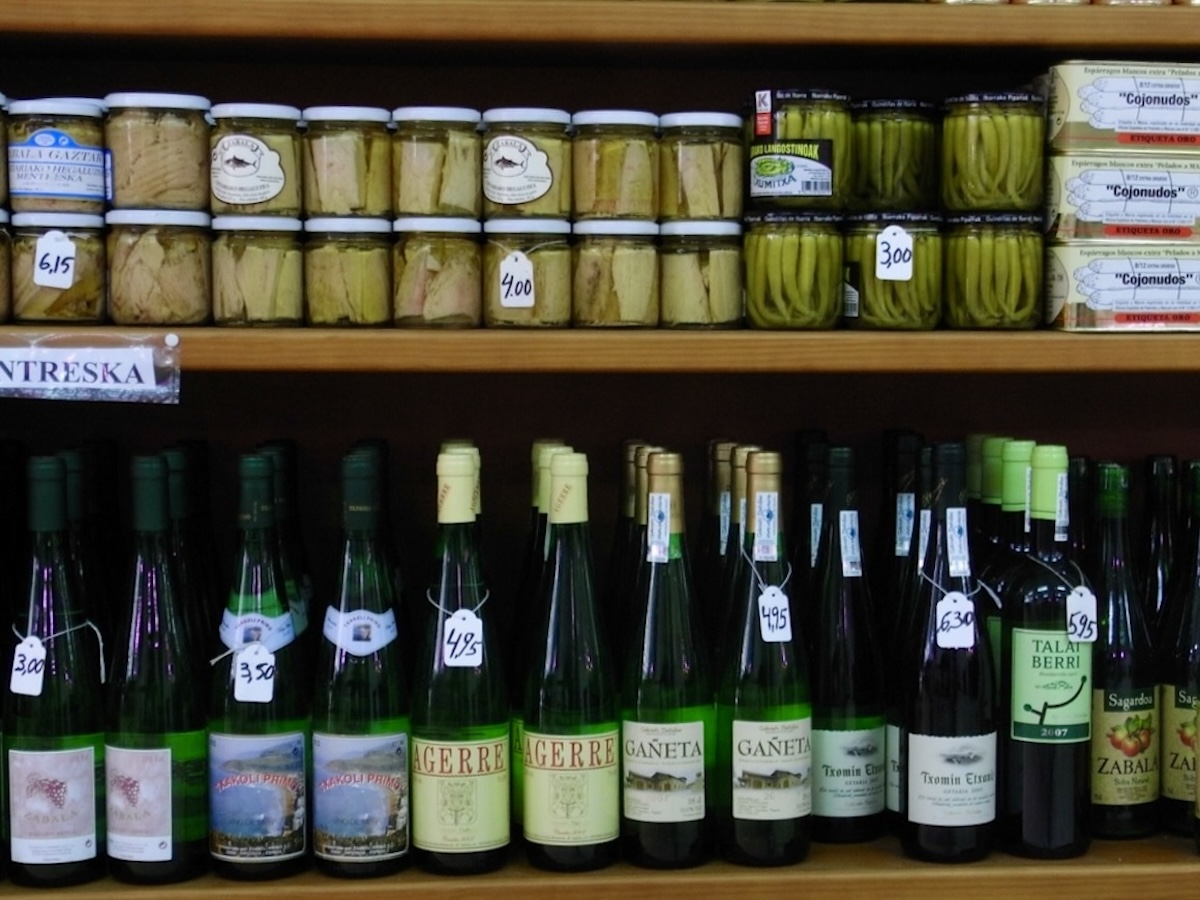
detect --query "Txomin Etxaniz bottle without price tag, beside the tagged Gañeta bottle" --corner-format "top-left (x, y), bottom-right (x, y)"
top-left (810, 446), bottom-right (886, 844)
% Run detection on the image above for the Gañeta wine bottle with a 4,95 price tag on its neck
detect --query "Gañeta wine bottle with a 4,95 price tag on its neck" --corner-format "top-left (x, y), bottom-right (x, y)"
top-left (716, 452), bottom-right (812, 865)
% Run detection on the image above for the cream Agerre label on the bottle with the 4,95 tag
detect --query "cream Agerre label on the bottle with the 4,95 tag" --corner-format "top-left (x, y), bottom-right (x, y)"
top-left (413, 722), bottom-right (509, 853)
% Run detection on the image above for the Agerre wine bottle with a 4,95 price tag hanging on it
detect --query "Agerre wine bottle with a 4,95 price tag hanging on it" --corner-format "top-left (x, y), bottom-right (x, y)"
top-left (412, 454), bottom-right (510, 875)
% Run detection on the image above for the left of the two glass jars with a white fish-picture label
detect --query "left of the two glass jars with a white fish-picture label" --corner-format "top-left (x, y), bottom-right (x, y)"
top-left (210, 103), bottom-right (302, 218)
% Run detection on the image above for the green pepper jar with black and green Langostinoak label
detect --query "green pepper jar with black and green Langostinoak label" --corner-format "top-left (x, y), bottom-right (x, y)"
top-left (750, 90), bottom-right (854, 210)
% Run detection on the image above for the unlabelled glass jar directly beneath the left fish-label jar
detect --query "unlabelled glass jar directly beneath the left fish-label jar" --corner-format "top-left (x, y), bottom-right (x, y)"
top-left (212, 216), bottom-right (304, 325)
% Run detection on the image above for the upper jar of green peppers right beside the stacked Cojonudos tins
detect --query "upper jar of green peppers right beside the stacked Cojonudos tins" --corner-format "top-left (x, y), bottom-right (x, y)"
top-left (942, 91), bottom-right (1045, 212)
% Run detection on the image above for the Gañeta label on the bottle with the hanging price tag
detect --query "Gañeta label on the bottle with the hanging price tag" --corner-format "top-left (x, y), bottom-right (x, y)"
top-left (733, 718), bottom-right (812, 822)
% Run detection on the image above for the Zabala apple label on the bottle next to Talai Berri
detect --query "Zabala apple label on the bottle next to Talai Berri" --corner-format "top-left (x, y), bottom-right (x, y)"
top-left (1092, 685), bottom-right (1162, 806)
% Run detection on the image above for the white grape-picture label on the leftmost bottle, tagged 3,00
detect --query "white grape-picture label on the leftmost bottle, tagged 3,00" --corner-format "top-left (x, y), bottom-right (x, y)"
top-left (8, 734), bottom-right (104, 864)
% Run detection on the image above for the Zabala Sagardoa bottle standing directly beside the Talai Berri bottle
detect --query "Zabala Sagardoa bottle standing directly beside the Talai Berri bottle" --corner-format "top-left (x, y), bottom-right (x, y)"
top-left (1091, 462), bottom-right (1162, 838)
